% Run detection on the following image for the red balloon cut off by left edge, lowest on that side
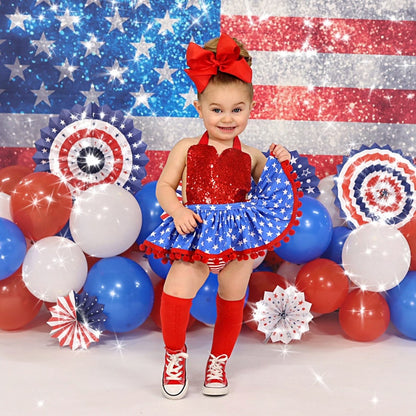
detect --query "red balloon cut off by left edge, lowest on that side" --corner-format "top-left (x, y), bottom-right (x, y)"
top-left (0, 268), bottom-right (43, 331)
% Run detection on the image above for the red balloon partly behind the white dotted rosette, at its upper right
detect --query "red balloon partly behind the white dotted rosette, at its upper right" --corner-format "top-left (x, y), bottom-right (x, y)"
top-left (296, 259), bottom-right (349, 313)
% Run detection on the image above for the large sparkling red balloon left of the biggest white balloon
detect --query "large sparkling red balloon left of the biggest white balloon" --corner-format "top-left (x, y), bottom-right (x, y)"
top-left (10, 172), bottom-right (72, 241)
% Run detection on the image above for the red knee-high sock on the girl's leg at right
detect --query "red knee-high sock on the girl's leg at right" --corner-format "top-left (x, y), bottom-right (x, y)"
top-left (211, 296), bottom-right (245, 357)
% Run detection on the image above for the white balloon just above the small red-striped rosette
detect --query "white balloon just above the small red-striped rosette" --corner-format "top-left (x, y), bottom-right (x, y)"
top-left (22, 236), bottom-right (88, 302)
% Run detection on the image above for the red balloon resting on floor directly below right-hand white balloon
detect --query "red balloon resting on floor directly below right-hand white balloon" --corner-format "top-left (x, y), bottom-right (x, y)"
top-left (338, 289), bottom-right (390, 341)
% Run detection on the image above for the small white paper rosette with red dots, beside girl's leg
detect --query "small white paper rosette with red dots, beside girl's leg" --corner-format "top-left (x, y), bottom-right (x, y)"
top-left (253, 286), bottom-right (313, 344)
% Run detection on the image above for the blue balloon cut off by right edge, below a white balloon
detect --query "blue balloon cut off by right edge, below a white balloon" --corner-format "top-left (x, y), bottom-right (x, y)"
top-left (386, 271), bottom-right (416, 339)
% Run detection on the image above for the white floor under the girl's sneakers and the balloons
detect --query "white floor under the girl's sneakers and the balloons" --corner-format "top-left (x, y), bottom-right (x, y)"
top-left (0, 310), bottom-right (416, 416)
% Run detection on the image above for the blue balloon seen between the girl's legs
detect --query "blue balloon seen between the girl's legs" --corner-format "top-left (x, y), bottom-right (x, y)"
top-left (191, 273), bottom-right (248, 325)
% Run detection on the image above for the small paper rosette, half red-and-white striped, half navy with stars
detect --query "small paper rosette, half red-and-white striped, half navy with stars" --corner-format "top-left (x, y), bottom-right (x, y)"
top-left (47, 291), bottom-right (107, 350)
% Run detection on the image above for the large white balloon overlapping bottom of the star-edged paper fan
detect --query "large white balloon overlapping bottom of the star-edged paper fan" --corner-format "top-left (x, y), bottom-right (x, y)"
top-left (69, 184), bottom-right (142, 257)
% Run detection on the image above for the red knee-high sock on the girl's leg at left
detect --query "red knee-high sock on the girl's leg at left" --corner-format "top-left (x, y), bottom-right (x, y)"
top-left (160, 292), bottom-right (192, 351)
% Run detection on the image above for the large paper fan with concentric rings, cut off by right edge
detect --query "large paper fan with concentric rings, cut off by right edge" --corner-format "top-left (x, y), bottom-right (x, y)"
top-left (333, 144), bottom-right (416, 227)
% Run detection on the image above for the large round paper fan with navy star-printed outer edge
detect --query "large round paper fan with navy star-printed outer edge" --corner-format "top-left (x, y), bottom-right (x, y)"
top-left (33, 103), bottom-right (149, 196)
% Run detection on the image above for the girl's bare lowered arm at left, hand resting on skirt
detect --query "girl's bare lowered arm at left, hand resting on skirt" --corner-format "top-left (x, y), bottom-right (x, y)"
top-left (156, 140), bottom-right (202, 234)
